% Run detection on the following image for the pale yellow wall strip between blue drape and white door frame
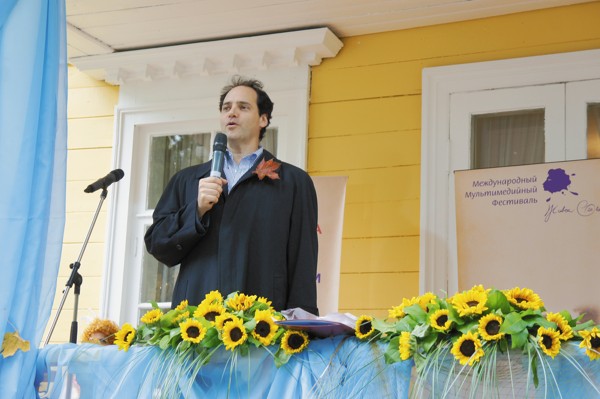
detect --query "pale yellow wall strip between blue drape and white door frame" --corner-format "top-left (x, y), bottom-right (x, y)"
top-left (44, 66), bottom-right (119, 343)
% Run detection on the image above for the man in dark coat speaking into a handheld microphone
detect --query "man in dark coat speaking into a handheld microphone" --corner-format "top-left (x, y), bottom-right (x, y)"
top-left (145, 77), bottom-right (318, 314)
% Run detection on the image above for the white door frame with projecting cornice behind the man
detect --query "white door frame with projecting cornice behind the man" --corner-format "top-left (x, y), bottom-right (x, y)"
top-left (70, 28), bottom-right (342, 324)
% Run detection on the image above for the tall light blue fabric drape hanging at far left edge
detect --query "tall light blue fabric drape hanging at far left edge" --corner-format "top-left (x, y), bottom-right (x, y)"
top-left (0, 0), bottom-right (67, 398)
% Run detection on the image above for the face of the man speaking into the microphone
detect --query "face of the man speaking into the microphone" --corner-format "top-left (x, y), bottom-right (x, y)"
top-left (220, 86), bottom-right (268, 145)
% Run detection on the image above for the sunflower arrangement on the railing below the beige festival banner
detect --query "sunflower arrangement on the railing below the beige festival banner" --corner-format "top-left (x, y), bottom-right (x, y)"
top-left (356, 285), bottom-right (600, 396)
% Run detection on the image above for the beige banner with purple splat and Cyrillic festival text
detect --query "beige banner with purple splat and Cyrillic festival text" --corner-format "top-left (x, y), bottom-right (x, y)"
top-left (455, 159), bottom-right (600, 320)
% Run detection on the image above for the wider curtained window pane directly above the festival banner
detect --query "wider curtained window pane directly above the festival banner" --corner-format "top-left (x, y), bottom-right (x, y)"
top-left (471, 109), bottom-right (545, 169)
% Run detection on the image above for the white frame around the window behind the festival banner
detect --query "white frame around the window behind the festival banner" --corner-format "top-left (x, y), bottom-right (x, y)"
top-left (419, 50), bottom-right (600, 294)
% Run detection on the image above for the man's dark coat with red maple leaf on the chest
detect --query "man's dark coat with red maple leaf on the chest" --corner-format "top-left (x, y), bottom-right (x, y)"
top-left (144, 151), bottom-right (318, 314)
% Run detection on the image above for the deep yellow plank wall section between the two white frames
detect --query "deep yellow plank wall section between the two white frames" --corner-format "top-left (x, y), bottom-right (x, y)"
top-left (308, 2), bottom-right (600, 316)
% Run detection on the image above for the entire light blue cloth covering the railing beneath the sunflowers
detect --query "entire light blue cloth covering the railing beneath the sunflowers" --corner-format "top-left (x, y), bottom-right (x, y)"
top-left (36, 336), bottom-right (600, 399)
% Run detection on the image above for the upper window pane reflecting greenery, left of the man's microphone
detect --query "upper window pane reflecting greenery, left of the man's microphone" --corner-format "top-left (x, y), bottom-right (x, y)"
top-left (146, 133), bottom-right (211, 209)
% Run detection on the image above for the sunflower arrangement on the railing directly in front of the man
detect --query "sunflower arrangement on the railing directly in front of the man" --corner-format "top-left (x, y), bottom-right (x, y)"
top-left (115, 291), bottom-right (309, 397)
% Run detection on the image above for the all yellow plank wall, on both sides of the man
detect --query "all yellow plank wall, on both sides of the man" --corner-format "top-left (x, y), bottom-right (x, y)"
top-left (51, 2), bottom-right (600, 342)
